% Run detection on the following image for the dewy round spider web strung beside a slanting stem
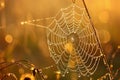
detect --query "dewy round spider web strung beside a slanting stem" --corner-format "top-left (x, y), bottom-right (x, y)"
top-left (22, 4), bottom-right (102, 77)
